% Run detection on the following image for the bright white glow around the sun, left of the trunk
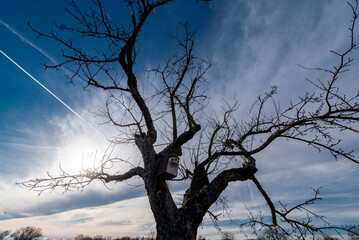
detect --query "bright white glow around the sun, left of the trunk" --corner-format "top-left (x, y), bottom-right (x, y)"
top-left (45, 99), bottom-right (140, 180)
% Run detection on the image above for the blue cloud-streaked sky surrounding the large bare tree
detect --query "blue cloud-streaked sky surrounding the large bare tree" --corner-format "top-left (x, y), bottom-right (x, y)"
top-left (0, 0), bottom-right (359, 239)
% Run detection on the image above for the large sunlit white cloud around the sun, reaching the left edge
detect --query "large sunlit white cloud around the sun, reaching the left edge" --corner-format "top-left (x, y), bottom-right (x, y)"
top-left (0, 86), bottom-right (143, 219)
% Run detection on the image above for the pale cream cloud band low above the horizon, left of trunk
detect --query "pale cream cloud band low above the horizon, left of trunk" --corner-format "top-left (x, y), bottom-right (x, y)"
top-left (0, 198), bottom-right (154, 237)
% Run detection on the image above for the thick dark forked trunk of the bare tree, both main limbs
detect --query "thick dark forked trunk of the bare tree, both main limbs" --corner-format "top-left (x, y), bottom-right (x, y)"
top-left (136, 135), bottom-right (245, 240)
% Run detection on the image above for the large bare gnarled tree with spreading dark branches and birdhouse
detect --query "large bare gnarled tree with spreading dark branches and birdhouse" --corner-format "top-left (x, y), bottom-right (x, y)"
top-left (23, 0), bottom-right (359, 240)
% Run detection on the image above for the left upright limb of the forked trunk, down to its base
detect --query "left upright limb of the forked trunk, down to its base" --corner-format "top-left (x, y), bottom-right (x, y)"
top-left (136, 135), bottom-right (198, 240)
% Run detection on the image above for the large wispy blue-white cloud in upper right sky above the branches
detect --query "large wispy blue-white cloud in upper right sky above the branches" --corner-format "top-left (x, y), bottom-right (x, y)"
top-left (209, 1), bottom-right (358, 112)
